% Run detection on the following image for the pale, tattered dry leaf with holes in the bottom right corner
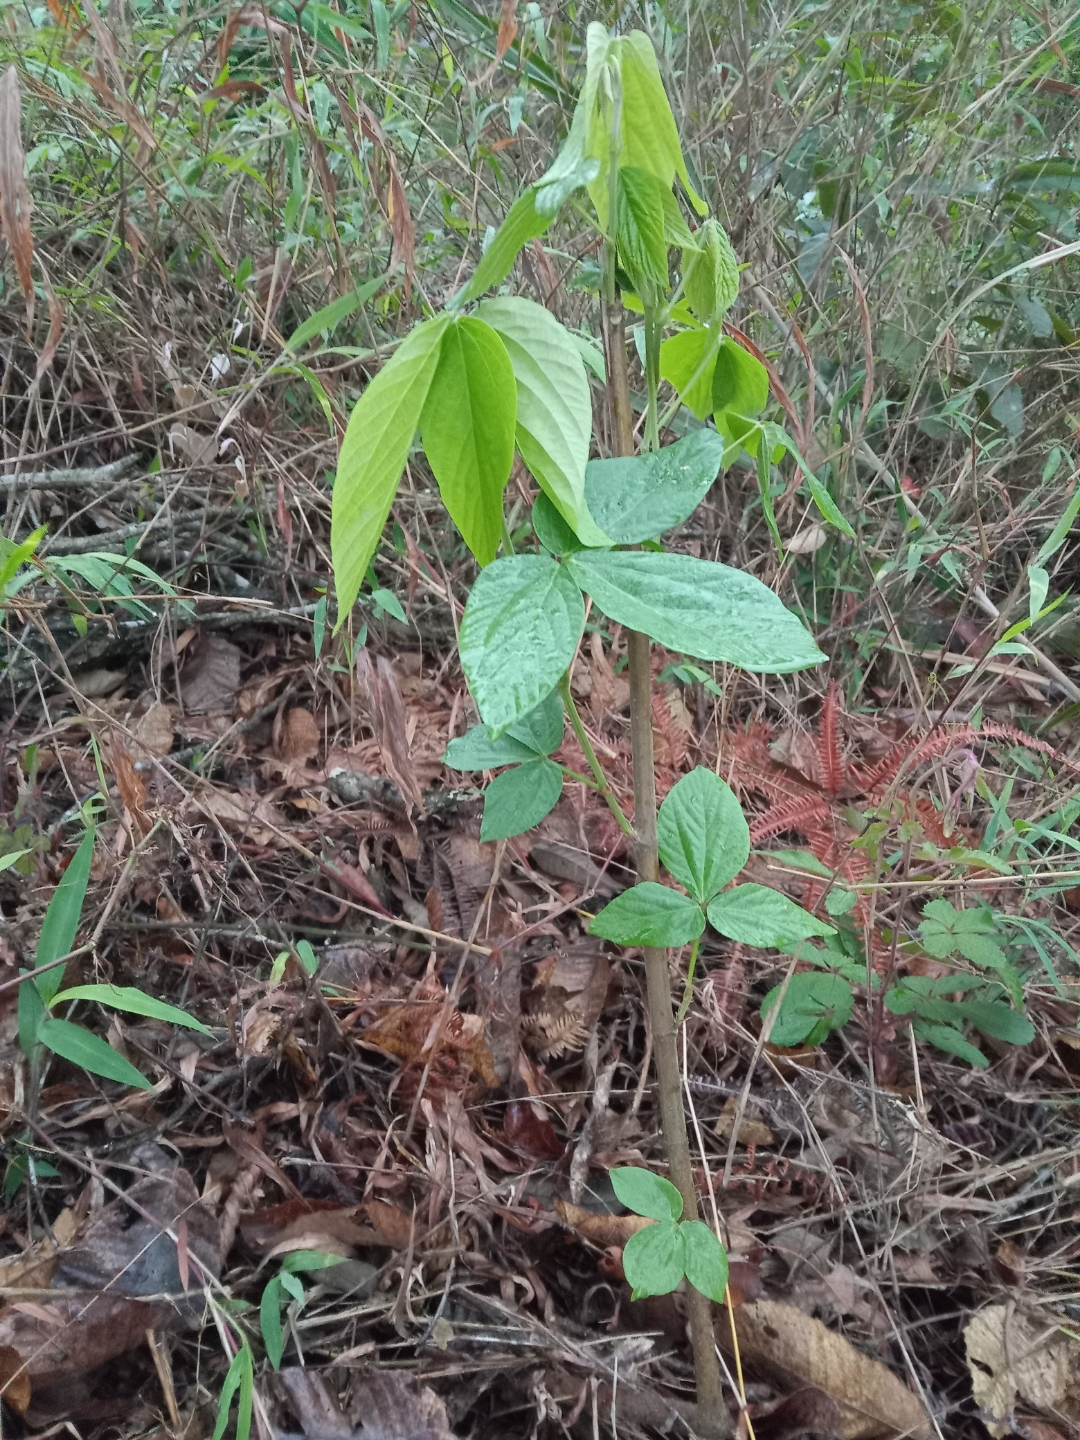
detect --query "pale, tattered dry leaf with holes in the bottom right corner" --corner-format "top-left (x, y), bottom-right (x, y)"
top-left (963, 1305), bottom-right (1080, 1434)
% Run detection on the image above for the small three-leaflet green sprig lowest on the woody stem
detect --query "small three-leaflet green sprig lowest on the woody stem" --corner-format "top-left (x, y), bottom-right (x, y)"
top-left (608, 1165), bottom-right (727, 1303)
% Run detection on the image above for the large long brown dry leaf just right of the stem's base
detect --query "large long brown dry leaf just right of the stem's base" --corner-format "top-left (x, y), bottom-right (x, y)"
top-left (734, 1300), bottom-right (933, 1440)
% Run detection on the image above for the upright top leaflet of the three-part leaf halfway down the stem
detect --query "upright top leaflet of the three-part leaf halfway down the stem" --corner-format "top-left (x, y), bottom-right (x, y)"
top-left (657, 766), bottom-right (750, 904)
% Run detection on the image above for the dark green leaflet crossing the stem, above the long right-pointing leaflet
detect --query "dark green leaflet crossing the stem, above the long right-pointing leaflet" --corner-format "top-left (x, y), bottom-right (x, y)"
top-left (585, 429), bottom-right (724, 544)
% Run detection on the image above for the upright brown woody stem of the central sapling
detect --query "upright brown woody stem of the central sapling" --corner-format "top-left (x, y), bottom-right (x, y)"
top-left (603, 287), bottom-right (730, 1436)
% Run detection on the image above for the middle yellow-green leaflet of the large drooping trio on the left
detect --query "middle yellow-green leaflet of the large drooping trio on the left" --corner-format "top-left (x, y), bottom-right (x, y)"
top-left (420, 315), bottom-right (517, 564)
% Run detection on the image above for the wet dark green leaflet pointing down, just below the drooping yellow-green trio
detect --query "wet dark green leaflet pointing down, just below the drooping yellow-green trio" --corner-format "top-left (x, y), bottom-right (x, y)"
top-left (459, 554), bottom-right (585, 739)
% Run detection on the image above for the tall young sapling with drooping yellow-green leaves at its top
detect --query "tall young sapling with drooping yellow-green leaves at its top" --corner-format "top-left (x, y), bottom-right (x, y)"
top-left (331, 24), bottom-right (838, 1430)
